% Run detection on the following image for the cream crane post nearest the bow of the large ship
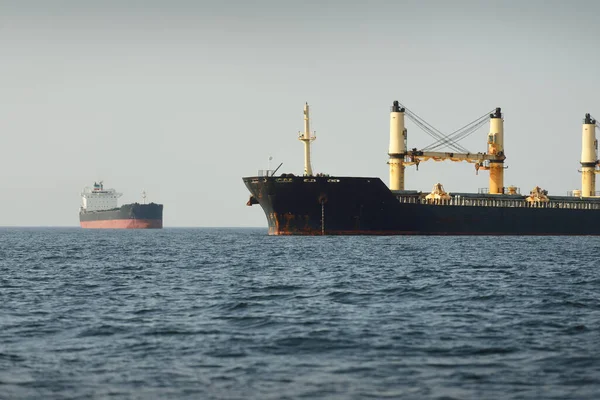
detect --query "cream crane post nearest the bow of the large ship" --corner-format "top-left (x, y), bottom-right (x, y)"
top-left (388, 100), bottom-right (407, 190)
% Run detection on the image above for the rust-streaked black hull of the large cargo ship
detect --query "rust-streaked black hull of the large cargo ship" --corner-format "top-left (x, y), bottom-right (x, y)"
top-left (243, 177), bottom-right (600, 235)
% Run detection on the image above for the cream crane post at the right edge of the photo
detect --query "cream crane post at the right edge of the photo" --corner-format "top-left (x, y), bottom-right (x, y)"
top-left (581, 114), bottom-right (598, 197)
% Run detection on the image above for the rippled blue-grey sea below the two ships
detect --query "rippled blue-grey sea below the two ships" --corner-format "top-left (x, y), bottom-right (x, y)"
top-left (0, 228), bottom-right (600, 400)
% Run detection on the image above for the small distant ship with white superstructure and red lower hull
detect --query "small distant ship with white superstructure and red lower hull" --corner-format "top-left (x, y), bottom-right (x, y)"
top-left (79, 182), bottom-right (163, 229)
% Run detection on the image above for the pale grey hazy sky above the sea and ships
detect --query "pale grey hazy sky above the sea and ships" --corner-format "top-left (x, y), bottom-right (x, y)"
top-left (0, 0), bottom-right (600, 227)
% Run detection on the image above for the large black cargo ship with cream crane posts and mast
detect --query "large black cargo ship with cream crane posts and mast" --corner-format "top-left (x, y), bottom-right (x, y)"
top-left (243, 102), bottom-right (600, 235)
